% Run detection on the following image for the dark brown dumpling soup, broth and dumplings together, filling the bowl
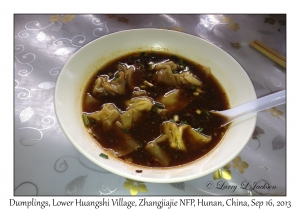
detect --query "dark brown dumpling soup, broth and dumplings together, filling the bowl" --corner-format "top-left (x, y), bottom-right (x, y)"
top-left (82, 51), bottom-right (229, 167)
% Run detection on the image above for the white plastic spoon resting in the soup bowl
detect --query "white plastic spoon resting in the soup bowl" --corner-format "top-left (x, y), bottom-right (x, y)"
top-left (210, 90), bottom-right (286, 127)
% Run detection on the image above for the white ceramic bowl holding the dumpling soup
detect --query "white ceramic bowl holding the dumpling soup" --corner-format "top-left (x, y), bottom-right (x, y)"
top-left (55, 29), bottom-right (257, 183)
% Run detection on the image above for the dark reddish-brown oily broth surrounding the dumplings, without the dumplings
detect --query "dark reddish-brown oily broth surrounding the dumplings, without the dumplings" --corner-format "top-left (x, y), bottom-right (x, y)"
top-left (82, 51), bottom-right (229, 167)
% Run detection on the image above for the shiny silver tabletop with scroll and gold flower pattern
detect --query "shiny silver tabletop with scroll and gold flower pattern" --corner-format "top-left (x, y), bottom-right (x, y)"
top-left (14, 14), bottom-right (286, 196)
